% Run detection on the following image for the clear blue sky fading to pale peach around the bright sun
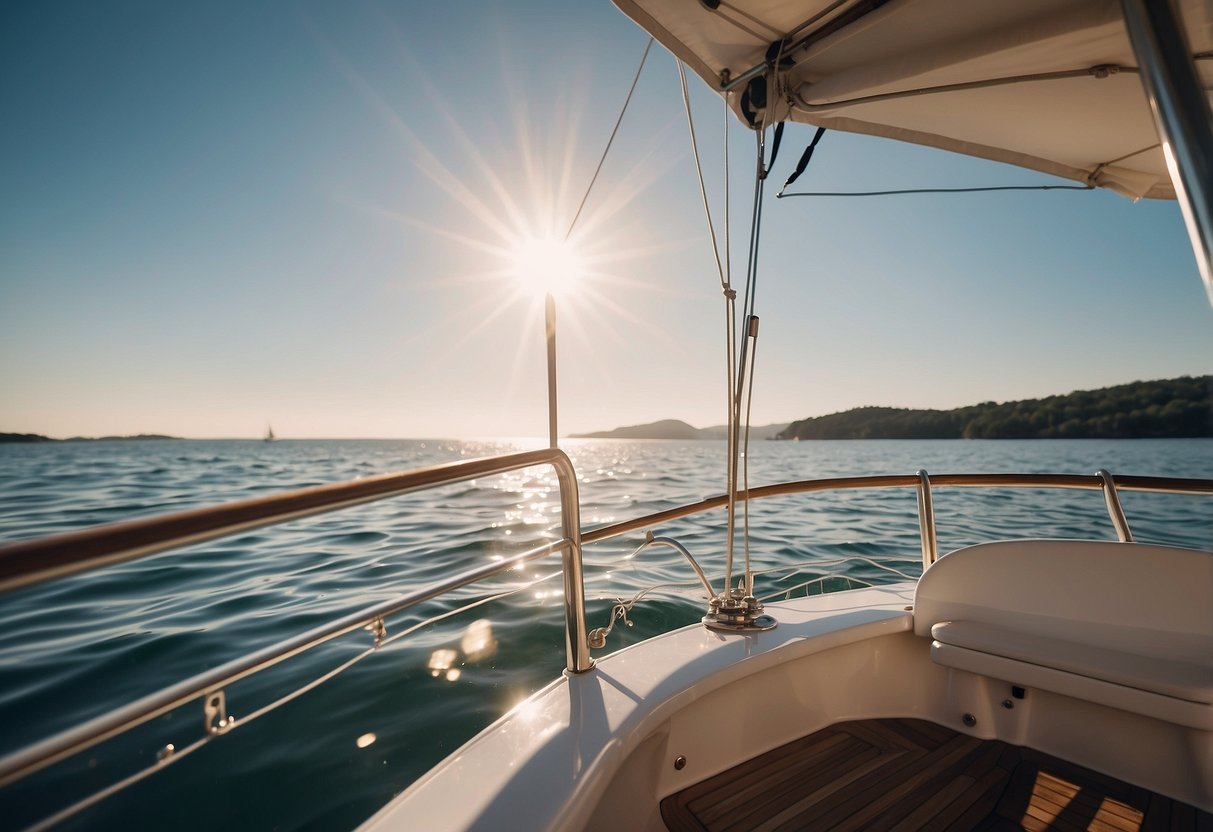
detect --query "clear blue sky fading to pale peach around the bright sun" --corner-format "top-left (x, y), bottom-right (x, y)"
top-left (0, 0), bottom-right (1213, 438)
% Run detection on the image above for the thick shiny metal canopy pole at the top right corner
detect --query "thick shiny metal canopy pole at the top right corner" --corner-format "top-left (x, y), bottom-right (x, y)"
top-left (1121, 0), bottom-right (1213, 303)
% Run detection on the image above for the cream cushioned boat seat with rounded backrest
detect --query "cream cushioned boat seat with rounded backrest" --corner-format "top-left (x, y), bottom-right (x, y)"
top-left (915, 540), bottom-right (1213, 730)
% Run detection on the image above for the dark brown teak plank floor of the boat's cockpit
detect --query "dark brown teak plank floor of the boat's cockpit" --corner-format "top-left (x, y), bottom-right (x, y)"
top-left (661, 719), bottom-right (1213, 832)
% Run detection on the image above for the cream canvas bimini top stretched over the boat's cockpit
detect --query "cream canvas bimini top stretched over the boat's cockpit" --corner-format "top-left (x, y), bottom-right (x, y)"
top-left (615, 0), bottom-right (1213, 199)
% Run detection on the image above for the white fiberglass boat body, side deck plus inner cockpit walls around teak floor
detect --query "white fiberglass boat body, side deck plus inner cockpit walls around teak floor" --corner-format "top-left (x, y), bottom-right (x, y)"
top-left (364, 545), bottom-right (1213, 830)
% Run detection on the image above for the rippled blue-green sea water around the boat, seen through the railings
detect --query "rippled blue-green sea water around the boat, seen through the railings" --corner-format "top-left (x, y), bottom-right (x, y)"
top-left (0, 439), bottom-right (1213, 830)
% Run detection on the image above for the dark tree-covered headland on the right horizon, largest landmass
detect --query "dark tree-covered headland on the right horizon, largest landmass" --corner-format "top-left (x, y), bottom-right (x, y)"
top-left (778, 376), bottom-right (1213, 439)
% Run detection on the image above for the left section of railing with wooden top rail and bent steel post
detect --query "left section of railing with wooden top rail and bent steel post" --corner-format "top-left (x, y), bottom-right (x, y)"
top-left (0, 449), bottom-right (593, 786)
